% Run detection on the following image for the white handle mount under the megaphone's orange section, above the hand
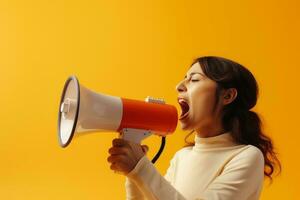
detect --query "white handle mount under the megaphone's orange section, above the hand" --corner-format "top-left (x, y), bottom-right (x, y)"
top-left (119, 128), bottom-right (152, 144)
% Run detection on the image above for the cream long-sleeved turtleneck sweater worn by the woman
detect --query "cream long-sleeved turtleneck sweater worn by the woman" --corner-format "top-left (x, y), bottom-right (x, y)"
top-left (125, 132), bottom-right (264, 200)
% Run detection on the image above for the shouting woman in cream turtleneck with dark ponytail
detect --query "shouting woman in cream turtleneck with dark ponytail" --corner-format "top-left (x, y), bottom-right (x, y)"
top-left (108, 56), bottom-right (280, 200)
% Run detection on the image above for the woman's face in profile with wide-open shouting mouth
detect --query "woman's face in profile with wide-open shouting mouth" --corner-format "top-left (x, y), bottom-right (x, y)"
top-left (176, 63), bottom-right (219, 132)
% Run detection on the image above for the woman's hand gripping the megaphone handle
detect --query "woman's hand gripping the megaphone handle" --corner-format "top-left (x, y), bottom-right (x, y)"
top-left (107, 138), bottom-right (149, 175)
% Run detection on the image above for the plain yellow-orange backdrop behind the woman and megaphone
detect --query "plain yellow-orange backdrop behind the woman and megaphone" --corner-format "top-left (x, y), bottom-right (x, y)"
top-left (0, 0), bottom-right (300, 200)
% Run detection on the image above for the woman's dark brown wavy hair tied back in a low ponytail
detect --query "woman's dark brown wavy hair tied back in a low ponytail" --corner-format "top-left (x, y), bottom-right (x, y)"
top-left (185, 56), bottom-right (281, 182)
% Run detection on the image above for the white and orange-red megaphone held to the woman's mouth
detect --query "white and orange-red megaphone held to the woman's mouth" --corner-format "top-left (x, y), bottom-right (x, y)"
top-left (58, 76), bottom-right (178, 150)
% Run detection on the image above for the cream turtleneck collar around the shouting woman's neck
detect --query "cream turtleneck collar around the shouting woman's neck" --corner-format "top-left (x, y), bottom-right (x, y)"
top-left (193, 132), bottom-right (236, 150)
